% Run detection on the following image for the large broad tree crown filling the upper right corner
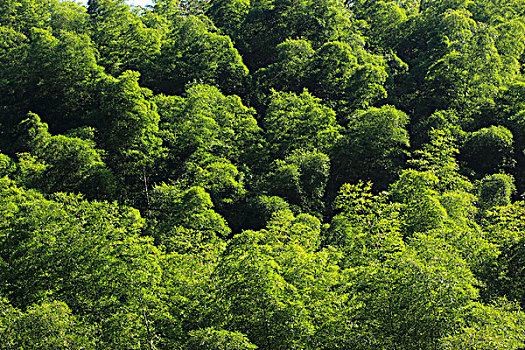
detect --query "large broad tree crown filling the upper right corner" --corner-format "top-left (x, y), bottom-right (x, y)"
top-left (384, 1), bottom-right (521, 119)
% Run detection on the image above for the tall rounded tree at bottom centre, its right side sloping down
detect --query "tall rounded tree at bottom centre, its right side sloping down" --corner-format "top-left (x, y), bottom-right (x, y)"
top-left (213, 232), bottom-right (310, 349)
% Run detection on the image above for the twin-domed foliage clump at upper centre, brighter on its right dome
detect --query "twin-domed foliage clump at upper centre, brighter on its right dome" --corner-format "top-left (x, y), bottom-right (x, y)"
top-left (256, 40), bottom-right (387, 115)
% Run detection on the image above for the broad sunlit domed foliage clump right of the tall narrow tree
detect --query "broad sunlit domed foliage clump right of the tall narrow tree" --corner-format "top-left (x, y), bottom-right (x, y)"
top-left (156, 85), bottom-right (262, 174)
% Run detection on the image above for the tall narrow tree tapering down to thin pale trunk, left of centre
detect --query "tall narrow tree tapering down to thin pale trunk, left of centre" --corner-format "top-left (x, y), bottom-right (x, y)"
top-left (92, 71), bottom-right (162, 207)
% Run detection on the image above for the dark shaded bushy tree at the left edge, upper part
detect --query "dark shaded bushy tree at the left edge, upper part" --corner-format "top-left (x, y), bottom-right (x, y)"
top-left (0, 28), bottom-right (101, 132)
